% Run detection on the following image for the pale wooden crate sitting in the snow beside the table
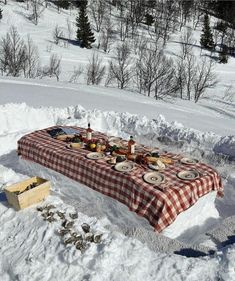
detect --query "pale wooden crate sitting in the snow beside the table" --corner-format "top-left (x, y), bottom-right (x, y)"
top-left (4, 177), bottom-right (51, 211)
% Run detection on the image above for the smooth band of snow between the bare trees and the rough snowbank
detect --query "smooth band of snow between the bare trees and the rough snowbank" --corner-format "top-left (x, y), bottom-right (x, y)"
top-left (0, 75), bottom-right (235, 136)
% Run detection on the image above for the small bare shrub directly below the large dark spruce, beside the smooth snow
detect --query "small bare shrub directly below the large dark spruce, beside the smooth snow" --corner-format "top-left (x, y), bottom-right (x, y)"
top-left (87, 53), bottom-right (105, 85)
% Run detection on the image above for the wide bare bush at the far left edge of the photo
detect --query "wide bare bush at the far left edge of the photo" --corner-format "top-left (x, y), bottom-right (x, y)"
top-left (0, 26), bottom-right (25, 76)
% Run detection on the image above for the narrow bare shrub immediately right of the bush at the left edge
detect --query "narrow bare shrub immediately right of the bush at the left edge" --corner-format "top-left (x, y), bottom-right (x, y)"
top-left (24, 35), bottom-right (39, 78)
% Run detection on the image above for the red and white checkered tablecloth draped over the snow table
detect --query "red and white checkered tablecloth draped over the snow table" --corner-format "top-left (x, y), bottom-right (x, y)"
top-left (18, 127), bottom-right (223, 232)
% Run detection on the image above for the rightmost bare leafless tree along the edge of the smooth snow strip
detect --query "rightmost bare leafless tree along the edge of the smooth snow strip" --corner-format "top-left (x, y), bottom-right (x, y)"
top-left (194, 58), bottom-right (217, 102)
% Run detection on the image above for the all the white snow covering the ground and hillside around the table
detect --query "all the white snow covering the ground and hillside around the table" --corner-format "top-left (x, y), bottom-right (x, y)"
top-left (0, 1), bottom-right (235, 281)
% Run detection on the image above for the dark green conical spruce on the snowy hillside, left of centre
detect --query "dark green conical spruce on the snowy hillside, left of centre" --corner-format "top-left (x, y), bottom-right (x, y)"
top-left (76, 0), bottom-right (95, 49)
